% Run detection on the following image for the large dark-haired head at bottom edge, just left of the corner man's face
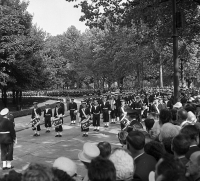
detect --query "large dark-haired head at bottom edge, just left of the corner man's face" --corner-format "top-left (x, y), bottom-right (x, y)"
top-left (155, 154), bottom-right (186, 181)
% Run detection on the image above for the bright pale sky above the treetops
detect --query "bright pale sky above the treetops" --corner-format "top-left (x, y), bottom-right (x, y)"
top-left (24, 0), bottom-right (87, 36)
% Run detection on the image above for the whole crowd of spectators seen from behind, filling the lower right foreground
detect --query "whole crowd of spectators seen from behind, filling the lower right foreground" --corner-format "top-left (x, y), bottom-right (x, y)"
top-left (0, 99), bottom-right (200, 181)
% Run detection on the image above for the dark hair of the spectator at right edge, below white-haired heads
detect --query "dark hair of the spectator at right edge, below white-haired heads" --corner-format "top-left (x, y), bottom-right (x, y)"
top-left (180, 125), bottom-right (199, 144)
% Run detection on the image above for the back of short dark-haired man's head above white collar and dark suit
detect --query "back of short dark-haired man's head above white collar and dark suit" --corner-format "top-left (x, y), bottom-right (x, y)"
top-left (126, 131), bottom-right (145, 151)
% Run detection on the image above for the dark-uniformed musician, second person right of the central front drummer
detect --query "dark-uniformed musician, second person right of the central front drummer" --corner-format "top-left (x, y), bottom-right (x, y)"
top-left (101, 96), bottom-right (111, 128)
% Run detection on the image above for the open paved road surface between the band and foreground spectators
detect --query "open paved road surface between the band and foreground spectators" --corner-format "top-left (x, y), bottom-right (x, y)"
top-left (0, 100), bottom-right (120, 175)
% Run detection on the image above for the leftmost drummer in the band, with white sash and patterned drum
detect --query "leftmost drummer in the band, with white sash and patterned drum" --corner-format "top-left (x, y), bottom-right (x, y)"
top-left (31, 102), bottom-right (42, 136)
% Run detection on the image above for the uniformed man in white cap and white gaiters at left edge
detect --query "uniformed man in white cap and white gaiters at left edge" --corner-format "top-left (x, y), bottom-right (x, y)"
top-left (0, 108), bottom-right (16, 170)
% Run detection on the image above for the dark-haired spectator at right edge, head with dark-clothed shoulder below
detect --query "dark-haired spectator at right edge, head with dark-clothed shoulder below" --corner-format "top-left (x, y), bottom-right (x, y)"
top-left (180, 125), bottom-right (200, 159)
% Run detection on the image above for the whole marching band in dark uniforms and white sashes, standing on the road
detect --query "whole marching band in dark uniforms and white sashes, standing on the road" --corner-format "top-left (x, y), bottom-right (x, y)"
top-left (23, 89), bottom-right (200, 137)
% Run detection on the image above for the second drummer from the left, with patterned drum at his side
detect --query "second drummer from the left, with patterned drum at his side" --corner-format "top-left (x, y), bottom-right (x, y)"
top-left (54, 101), bottom-right (64, 137)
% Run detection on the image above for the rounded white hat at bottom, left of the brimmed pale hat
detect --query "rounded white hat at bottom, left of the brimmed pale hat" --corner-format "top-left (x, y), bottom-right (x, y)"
top-left (53, 157), bottom-right (77, 178)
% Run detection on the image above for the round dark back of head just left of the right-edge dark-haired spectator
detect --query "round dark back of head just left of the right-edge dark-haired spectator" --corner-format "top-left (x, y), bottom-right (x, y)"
top-left (172, 134), bottom-right (190, 156)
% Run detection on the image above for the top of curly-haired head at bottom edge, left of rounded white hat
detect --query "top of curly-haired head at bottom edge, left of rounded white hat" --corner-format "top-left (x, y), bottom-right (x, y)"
top-left (22, 163), bottom-right (58, 181)
